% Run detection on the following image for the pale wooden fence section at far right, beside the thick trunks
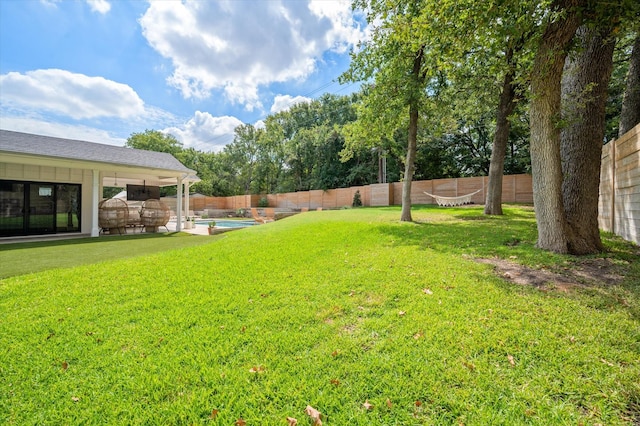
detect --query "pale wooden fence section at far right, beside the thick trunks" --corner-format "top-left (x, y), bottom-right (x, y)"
top-left (598, 124), bottom-right (640, 244)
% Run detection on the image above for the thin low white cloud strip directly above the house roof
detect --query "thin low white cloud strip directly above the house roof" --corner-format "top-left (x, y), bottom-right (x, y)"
top-left (0, 115), bottom-right (127, 146)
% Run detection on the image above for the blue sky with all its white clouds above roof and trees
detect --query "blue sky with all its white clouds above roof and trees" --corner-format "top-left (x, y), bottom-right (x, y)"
top-left (0, 0), bottom-right (367, 151)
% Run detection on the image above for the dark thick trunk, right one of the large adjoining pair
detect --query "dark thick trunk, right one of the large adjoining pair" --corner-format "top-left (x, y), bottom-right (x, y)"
top-left (560, 26), bottom-right (615, 254)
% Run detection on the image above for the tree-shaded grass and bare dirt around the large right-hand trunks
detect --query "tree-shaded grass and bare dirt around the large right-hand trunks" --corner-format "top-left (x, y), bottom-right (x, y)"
top-left (379, 211), bottom-right (640, 319)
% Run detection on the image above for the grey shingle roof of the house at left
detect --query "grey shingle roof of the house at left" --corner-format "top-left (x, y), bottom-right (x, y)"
top-left (0, 129), bottom-right (194, 173)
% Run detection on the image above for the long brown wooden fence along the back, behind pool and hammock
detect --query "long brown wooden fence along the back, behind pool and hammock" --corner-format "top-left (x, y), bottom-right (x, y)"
top-left (163, 174), bottom-right (533, 212)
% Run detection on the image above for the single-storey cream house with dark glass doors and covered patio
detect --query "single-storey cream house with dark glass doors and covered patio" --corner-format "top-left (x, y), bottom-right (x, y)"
top-left (0, 129), bottom-right (199, 242)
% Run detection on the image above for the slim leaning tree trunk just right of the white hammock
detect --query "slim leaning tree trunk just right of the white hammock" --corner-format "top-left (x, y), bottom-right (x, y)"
top-left (484, 48), bottom-right (516, 215)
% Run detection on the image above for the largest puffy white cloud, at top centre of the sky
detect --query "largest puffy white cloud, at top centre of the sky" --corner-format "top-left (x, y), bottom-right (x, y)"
top-left (140, 0), bottom-right (364, 110)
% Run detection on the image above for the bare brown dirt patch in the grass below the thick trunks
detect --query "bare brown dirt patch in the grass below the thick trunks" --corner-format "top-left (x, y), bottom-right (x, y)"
top-left (476, 258), bottom-right (624, 291)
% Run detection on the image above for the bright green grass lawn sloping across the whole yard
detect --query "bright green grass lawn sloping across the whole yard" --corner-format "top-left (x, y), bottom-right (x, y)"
top-left (0, 206), bottom-right (640, 425)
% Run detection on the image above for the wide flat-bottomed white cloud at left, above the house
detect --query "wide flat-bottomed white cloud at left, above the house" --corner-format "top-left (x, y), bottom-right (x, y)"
top-left (0, 69), bottom-right (145, 120)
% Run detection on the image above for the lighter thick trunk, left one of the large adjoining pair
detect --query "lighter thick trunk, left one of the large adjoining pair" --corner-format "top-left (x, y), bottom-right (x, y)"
top-left (530, 1), bottom-right (580, 253)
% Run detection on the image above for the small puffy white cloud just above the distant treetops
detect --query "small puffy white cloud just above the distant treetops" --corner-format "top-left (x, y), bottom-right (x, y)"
top-left (162, 111), bottom-right (242, 152)
